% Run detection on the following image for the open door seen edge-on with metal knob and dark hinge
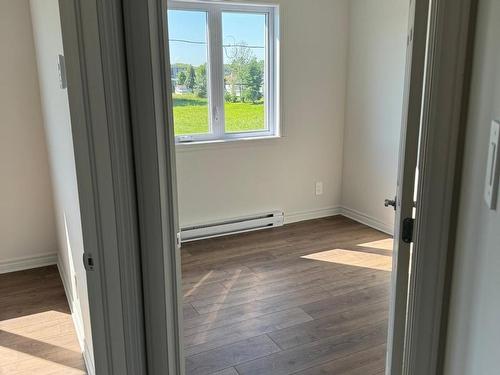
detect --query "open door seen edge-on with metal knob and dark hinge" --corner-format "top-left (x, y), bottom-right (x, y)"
top-left (386, 0), bottom-right (429, 375)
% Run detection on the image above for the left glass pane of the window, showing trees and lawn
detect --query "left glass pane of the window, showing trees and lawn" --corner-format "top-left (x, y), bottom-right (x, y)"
top-left (168, 10), bottom-right (211, 136)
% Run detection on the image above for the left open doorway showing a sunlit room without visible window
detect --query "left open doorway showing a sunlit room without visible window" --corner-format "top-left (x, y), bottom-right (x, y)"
top-left (0, 0), bottom-right (94, 374)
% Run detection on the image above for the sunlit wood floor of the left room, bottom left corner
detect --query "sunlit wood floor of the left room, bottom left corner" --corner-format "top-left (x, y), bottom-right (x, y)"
top-left (0, 266), bottom-right (86, 375)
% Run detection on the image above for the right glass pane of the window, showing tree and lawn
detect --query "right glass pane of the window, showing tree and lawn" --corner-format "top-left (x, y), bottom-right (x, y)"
top-left (222, 12), bottom-right (267, 133)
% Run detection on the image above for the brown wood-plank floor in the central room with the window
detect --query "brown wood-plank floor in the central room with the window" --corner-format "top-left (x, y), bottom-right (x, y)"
top-left (182, 216), bottom-right (392, 375)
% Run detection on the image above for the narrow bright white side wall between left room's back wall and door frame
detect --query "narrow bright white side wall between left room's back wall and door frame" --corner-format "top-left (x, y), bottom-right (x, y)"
top-left (30, 0), bottom-right (92, 370)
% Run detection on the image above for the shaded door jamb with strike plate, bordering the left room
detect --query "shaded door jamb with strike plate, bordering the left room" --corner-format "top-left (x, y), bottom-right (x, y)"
top-left (59, 0), bottom-right (147, 375)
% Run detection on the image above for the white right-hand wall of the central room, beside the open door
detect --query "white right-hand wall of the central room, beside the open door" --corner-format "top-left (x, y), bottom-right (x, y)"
top-left (342, 0), bottom-right (409, 232)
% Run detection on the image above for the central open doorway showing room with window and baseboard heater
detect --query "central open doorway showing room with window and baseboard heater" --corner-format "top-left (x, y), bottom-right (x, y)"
top-left (168, 1), bottom-right (410, 375)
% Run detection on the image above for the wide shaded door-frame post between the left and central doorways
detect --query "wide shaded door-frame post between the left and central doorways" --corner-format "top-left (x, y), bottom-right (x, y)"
top-left (59, 0), bottom-right (184, 375)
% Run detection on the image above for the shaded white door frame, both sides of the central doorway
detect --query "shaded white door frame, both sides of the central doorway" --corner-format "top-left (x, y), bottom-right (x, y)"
top-left (60, 0), bottom-right (477, 375)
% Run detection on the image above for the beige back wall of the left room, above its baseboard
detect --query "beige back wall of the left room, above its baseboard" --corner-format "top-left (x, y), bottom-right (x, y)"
top-left (0, 0), bottom-right (58, 272)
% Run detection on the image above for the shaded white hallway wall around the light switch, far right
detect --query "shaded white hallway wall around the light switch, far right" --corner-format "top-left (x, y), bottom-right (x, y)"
top-left (445, 0), bottom-right (500, 375)
